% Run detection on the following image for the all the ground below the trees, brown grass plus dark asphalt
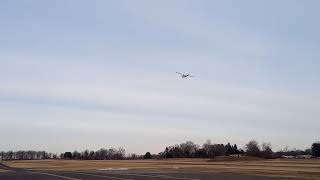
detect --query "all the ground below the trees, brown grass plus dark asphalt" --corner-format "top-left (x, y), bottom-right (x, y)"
top-left (0, 159), bottom-right (320, 180)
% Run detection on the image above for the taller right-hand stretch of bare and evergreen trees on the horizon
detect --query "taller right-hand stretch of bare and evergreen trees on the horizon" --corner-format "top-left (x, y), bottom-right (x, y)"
top-left (154, 140), bottom-right (320, 159)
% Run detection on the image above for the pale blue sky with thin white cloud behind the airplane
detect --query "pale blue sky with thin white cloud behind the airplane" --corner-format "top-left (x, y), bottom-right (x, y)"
top-left (0, 0), bottom-right (320, 154)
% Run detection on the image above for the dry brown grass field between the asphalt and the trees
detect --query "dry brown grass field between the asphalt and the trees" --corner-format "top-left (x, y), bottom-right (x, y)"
top-left (5, 159), bottom-right (320, 179)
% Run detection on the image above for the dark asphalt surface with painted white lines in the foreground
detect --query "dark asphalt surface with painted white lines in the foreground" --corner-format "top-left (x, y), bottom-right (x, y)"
top-left (0, 164), bottom-right (300, 180)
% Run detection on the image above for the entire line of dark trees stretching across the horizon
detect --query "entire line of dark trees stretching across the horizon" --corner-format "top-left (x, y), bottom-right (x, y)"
top-left (0, 140), bottom-right (320, 160)
